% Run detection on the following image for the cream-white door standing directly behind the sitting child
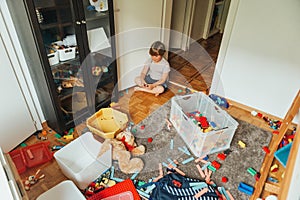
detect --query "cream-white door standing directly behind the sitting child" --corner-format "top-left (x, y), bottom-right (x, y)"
top-left (114, 0), bottom-right (172, 90)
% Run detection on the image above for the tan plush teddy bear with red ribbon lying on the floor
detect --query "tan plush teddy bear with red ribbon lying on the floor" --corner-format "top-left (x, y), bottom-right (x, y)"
top-left (98, 131), bottom-right (145, 174)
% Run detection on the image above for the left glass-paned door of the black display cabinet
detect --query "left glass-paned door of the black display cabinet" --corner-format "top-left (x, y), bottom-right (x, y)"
top-left (34, 0), bottom-right (87, 123)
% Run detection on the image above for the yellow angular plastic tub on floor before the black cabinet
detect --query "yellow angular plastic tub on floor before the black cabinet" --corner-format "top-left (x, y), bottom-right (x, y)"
top-left (86, 108), bottom-right (128, 138)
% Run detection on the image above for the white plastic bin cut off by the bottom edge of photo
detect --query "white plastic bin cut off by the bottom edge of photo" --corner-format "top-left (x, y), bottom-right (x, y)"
top-left (37, 180), bottom-right (86, 200)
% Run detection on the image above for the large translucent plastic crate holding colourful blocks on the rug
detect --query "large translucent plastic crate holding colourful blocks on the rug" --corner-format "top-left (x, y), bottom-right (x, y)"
top-left (170, 92), bottom-right (238, 157)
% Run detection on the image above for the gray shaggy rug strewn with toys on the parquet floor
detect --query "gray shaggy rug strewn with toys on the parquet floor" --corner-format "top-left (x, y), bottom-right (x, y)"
top-left (113, 101), bottom-right (272, 200)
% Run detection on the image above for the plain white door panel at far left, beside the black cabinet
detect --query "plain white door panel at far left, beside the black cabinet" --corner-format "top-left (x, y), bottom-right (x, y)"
top-left (0, 17), bottom-right (36, 152)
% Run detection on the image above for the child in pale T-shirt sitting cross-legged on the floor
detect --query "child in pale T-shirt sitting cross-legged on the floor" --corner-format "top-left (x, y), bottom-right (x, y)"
top-left (134, 41), bottom-right (170, 96)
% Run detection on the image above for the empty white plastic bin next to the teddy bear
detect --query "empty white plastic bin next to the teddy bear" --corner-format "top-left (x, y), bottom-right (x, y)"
top-left (54, 132), bottom-right (112, 189)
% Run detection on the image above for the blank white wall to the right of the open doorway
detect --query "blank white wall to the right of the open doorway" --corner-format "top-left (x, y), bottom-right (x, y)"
top-left (211, 0), bottom-right (300, 118)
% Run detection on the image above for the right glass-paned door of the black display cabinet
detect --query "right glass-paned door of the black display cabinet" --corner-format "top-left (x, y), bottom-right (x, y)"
top-left (80, 0), bottom-right (117, 111)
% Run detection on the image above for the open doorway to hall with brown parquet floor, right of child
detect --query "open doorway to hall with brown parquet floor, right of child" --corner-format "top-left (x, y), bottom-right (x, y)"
top-left (169, 0), bottom-right (231, 93)
